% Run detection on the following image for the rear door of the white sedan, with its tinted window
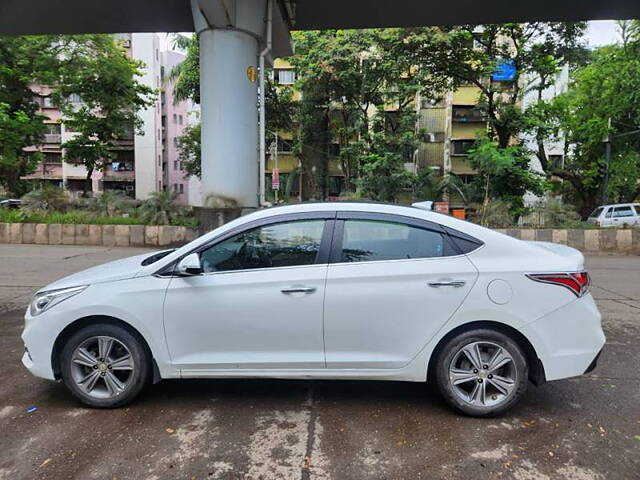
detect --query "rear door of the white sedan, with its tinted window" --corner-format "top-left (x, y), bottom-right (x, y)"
top-left (324, 212), bottom-right (480, 369)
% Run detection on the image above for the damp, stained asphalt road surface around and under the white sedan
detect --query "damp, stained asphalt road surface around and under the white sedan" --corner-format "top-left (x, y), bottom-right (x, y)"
top-left (0, 245), bottom-right (640, 480)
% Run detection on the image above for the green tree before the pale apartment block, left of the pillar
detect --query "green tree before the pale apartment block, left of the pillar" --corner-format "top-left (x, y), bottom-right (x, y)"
top-left (56, 35), bottom-right (155, 194)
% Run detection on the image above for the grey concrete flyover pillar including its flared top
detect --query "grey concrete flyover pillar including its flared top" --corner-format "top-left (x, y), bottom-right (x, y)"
top-left (191, 0), bottom-right (292, 208)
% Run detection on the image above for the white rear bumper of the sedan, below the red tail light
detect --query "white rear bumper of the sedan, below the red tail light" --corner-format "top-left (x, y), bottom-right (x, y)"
top-left (522, 294), bottom-right (606, 381)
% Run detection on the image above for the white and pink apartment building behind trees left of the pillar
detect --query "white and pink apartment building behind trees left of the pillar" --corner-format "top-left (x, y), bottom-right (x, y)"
top-left (25, 33), bottom-right (189, 203)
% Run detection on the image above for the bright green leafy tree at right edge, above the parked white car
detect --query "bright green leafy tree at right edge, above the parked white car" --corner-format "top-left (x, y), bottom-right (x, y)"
top-left (540, 43), bottom-right (640, 218)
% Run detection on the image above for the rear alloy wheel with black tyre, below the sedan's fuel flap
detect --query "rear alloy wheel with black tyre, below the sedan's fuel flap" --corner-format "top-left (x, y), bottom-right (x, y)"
top-left (435, 328), bottom-right (529, 417)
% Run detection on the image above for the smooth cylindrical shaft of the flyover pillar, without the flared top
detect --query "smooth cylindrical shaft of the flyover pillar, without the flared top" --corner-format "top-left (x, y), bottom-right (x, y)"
top-left (200, 29), bottom-right (258, 207)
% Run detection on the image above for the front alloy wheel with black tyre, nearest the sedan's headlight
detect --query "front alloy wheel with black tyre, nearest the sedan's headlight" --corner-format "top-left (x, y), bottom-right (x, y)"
top-left (60, 324), bottom-right (151, 408)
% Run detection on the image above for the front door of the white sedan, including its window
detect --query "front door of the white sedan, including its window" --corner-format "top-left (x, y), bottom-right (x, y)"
top-left (164, 219), bottom-right (331, 375)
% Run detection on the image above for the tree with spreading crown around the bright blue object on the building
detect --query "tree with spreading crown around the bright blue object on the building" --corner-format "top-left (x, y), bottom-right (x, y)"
top-left (421, 22), bottom-right (586, 148)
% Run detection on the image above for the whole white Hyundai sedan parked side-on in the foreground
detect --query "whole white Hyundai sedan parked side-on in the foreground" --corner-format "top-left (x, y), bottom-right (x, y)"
top-left (22, 203), bottom-right (605, 416)
